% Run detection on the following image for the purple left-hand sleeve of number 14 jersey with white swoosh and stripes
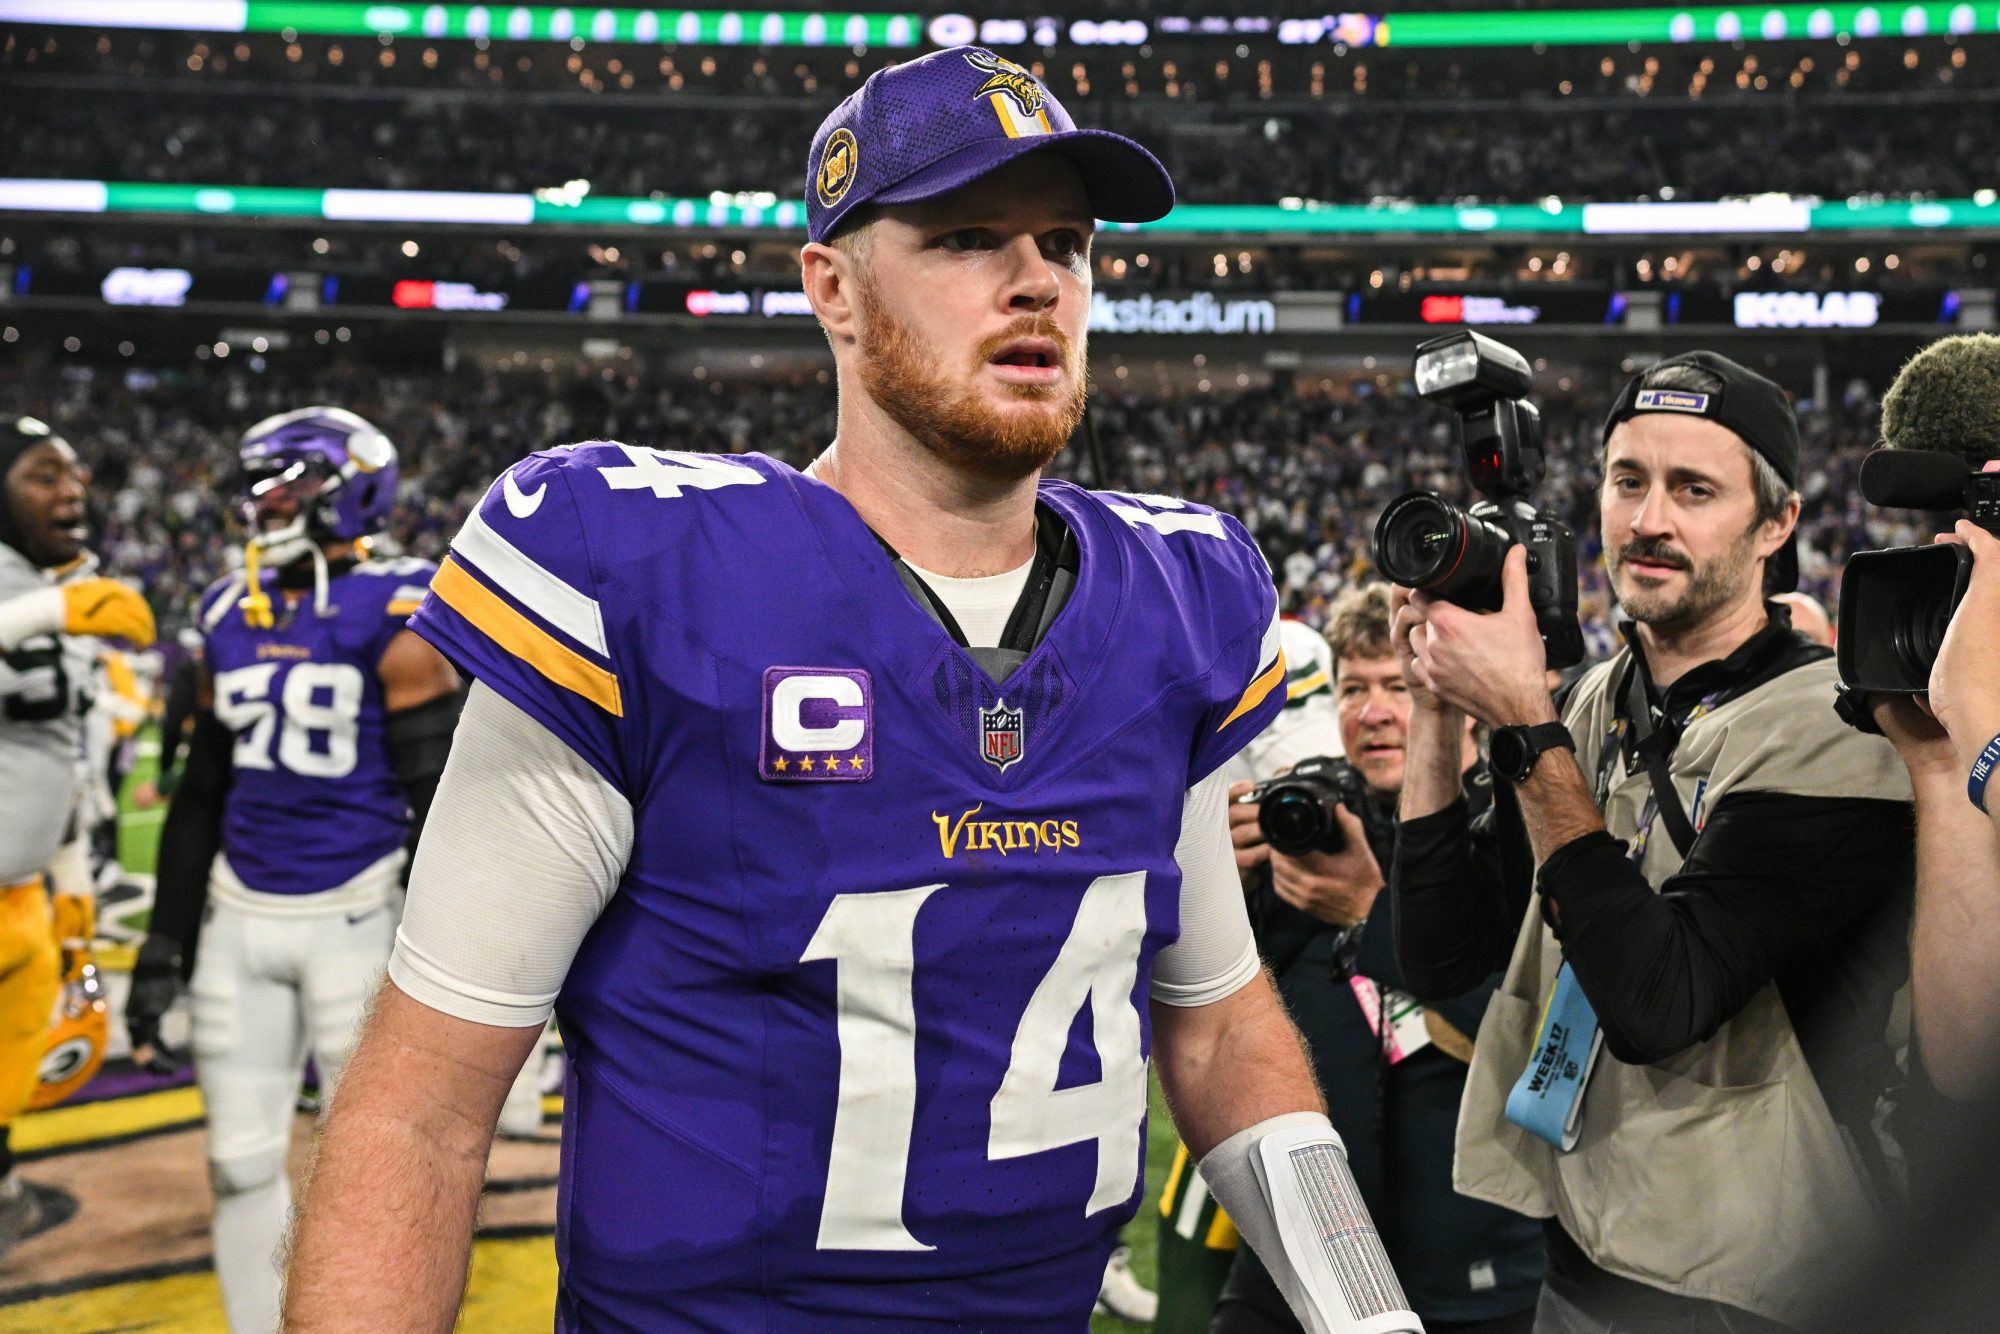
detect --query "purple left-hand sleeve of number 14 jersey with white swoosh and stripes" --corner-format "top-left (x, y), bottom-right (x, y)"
top-left (408, 450), bottom-right (626, 790)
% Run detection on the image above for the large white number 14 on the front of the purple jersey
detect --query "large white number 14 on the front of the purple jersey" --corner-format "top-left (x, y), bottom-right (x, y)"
top-left (800, 872), bottom-right (1146, 1250)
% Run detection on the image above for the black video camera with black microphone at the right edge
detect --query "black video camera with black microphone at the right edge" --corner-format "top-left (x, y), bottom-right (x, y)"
top-left (1836, 450), bottom-right (2000, 694)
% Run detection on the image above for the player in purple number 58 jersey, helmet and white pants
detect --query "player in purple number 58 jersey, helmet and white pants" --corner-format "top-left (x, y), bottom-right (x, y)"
top-left (126, 408), bottom-right (462, 1334)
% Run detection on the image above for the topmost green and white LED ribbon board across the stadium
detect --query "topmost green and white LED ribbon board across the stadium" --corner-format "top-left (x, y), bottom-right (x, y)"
top-left (0, 0), bottom-right (2000, 48)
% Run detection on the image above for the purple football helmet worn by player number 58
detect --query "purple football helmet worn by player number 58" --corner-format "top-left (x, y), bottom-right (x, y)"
top-left (236, 408), bottom-right (398, 564)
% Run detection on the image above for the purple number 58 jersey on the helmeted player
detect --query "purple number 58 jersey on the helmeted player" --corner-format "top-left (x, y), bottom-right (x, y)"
top-left (200, 560), bottom-right (436, 894)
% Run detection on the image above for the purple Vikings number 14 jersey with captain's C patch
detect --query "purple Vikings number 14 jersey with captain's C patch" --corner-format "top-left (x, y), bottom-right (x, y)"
top-left (410, 442), bottom-right (1284, 1334)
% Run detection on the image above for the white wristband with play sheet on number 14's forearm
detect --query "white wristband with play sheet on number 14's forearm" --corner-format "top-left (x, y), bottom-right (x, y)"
top-left (1200, 1112), bottom-right (1424, 1334)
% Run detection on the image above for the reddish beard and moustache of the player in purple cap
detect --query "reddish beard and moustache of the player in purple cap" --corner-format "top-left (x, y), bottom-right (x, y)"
top-left (858, 274), bottom-right (1086, 482)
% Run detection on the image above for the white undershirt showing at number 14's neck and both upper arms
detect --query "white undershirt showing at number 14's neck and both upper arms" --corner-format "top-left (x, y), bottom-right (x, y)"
top-left (388, 560), bottom-right (1258, 1028)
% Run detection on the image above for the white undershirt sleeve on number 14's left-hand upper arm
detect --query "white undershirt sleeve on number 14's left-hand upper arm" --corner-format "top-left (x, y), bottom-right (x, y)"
top-left (388, 682), bottom-right (632, 1028)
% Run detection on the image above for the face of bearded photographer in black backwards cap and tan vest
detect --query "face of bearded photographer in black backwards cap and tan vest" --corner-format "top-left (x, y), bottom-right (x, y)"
top-left (1598, 412), bottom-right (1792, 632)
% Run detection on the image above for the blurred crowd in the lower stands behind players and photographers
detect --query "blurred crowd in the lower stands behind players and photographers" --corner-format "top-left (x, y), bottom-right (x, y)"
top-left (0, 362), bottom-right (1904, 652)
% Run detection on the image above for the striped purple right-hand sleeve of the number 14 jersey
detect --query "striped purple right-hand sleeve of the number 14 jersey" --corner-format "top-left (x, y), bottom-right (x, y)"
top-left (1188, 514), bottom-right (1284, 788)
